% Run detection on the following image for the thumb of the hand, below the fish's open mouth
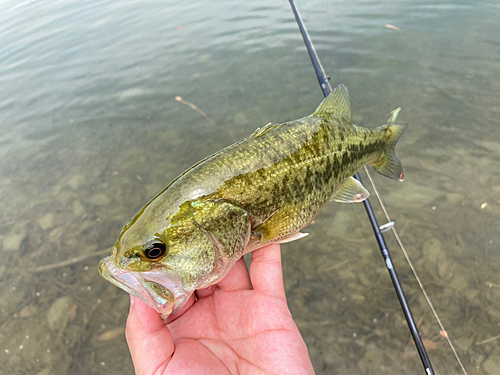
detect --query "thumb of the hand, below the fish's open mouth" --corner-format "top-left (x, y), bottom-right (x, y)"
top-left (125, 296), bottom-right (174, 375)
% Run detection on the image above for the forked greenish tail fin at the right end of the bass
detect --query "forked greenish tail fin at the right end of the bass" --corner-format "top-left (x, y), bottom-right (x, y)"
top-left (370, 123), bottom-right (408, 181)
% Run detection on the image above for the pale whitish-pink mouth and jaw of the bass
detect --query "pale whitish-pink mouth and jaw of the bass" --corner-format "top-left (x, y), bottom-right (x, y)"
top-left (99, 256), bottom-right (191, 319)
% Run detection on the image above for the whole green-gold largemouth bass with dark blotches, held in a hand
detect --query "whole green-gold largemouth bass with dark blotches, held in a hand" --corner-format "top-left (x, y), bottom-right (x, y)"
top-left (99, 85), bottom-right (407, 318)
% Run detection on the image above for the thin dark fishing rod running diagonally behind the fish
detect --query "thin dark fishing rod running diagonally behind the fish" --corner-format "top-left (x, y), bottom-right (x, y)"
top-left (288, 0), bottom-right (434, 375)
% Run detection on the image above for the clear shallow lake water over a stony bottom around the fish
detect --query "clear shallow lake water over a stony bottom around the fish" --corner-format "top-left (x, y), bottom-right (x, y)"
top-left (0, 0), bottom-right (500, 375)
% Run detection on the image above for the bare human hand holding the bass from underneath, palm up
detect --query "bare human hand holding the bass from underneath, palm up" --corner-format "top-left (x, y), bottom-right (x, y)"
top-left (126, 244), bottom-right (314, 375)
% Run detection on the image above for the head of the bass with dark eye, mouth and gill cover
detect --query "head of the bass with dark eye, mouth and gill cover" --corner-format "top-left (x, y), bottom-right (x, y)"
top-left (99, 197), bottom-right (250, 318)
